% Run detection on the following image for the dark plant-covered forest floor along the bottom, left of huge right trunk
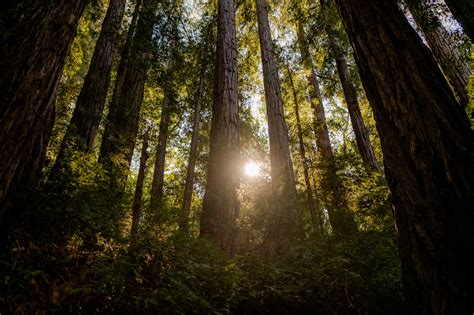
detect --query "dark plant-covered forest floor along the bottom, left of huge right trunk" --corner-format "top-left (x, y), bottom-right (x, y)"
top-left (0, 232), bottom-right (403, 314)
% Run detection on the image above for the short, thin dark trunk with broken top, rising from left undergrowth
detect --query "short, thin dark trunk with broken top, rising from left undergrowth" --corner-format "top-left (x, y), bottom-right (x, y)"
top-left (130, 129), bottom-right (149, 250)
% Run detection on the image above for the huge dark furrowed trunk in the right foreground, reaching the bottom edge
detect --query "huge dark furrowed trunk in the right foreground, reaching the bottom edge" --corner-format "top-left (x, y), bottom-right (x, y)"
top-left (337, 0), bottom-right (474, 314)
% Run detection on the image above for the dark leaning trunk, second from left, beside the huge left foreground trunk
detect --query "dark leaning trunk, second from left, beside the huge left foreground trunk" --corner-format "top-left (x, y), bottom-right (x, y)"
top-left (59, 0), bottom-right (126, 155)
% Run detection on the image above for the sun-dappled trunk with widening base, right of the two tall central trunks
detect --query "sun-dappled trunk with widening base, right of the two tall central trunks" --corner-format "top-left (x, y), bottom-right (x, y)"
top-left (297, 22), bottom-right (357, 235)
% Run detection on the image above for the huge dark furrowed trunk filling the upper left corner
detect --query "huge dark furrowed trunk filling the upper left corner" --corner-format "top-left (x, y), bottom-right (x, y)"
top-left (0, 0), bottom-right (86, 226)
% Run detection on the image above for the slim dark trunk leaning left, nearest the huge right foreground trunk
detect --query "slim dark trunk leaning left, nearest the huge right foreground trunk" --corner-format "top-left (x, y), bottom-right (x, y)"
top-left (320, 0), bottom-right (381, 171)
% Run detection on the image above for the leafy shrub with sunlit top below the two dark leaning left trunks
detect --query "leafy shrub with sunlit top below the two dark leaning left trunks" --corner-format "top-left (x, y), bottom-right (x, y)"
top-left (34, 149), bottom-right (131, 247)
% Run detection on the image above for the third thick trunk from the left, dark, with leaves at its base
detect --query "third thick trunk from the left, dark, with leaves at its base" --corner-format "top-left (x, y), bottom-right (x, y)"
top-left (99, 0), bottom-right (155, 170)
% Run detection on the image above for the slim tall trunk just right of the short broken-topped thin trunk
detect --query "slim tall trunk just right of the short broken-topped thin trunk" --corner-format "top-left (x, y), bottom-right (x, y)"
top-left (150, 0), bottom-right (179, 219)
